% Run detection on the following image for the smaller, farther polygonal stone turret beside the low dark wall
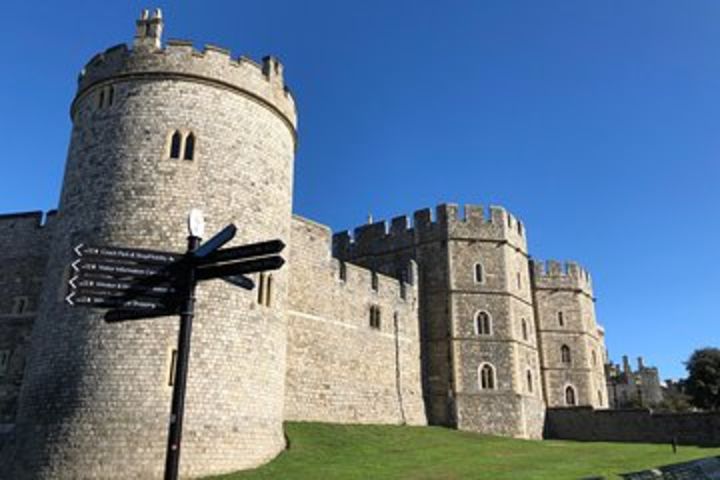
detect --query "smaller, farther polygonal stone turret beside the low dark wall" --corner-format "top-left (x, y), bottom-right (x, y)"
top-left (532, 260), bottom-right (608, 408)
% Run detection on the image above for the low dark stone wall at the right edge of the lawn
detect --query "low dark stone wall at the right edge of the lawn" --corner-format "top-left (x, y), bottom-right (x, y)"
top-left (545, 407), bottom-right (720, 446)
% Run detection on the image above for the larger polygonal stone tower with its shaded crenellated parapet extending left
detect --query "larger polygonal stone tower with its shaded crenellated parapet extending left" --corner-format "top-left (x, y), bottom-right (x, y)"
top-left (334, 204), bottom-right (544, 438)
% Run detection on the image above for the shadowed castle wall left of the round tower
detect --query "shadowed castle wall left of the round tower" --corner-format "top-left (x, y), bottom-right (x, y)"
top-left (0, 212), bottom-right (54, 424)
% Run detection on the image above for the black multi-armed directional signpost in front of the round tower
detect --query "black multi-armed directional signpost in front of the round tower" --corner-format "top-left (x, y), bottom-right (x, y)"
top-left (65, 210), bottom-right (285, 480)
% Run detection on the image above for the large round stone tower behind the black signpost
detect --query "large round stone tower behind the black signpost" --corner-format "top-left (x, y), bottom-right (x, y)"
top-left (12, 11), bottom-right (296, 479)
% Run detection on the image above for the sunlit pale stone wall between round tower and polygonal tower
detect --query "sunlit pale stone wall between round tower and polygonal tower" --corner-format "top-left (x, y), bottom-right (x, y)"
top-left (285, 216), bottom-right (426, 425)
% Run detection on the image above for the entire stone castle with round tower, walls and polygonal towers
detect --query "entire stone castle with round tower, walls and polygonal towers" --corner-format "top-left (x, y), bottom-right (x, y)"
top-left (0, 11), bottom-right (608, 479)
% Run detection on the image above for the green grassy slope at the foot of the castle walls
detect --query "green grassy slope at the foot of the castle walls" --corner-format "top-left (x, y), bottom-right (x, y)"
top-left (208, 423), bottom-right (720, 480)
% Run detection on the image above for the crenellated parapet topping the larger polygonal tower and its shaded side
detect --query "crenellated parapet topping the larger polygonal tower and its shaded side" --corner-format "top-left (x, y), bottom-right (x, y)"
top-left (333, 204), bottom-right (527, 258)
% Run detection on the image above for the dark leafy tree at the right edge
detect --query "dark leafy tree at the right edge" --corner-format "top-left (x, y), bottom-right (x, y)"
top-left (685, 348), bottom-right (720, 410)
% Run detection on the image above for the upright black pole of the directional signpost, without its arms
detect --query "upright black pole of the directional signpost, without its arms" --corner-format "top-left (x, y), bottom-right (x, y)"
top-left (165, 232), bottom-right (201, 480)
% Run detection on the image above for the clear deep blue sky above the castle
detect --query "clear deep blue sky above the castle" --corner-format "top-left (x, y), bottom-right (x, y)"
top-left (0, 0), bottom-right (720, 377)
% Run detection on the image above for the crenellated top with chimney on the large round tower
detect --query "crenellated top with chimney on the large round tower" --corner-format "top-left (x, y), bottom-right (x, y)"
top-left (72, 8), bottom-right (297, 130)
